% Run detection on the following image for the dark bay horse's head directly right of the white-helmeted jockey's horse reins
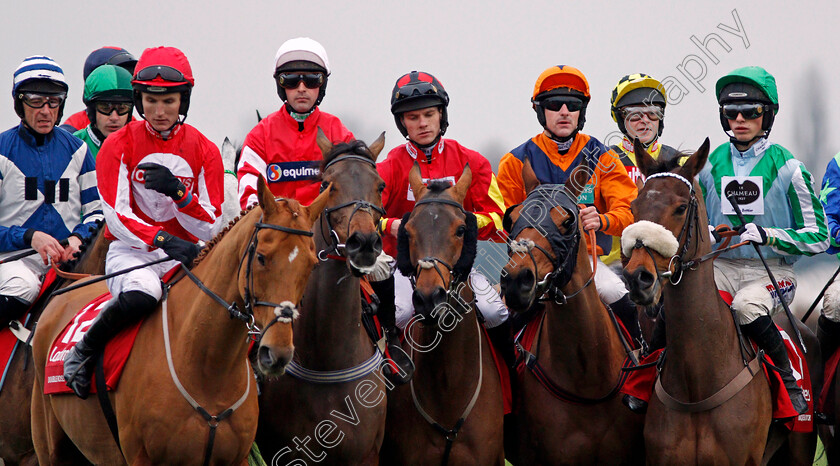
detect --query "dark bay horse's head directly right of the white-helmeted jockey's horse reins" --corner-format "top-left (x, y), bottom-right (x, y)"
top-left (317, 129), bottom-right (385, 275)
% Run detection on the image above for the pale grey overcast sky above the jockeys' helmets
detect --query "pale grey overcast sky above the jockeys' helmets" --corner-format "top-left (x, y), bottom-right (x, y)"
top-left (0, 0), bottom-right (840, 183)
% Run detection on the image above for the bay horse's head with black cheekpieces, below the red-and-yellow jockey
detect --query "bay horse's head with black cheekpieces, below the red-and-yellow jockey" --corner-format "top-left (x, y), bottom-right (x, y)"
top-left (397, 162), bottom-right (478, 325)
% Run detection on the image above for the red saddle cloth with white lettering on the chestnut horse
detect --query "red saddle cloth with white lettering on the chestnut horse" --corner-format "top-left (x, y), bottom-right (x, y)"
top-left (44, 293), bottom-right (143, 395)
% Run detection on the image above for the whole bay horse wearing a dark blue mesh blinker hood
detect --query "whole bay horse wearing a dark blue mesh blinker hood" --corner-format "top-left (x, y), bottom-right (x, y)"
top-left (501, 161), bottom-right (644, 464)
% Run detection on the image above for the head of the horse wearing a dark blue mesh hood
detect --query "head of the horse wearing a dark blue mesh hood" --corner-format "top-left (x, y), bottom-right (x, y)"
top-left (501, 160), bottom-right (592, 312)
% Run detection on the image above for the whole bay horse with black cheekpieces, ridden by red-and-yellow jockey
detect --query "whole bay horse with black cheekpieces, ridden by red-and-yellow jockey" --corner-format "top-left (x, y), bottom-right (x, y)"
top-left (382, 163), bottom-right (504, 465)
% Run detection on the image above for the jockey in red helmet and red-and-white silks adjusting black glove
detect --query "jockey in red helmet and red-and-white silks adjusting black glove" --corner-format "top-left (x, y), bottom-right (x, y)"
top-left (64, 47), bottom-right (224, 398)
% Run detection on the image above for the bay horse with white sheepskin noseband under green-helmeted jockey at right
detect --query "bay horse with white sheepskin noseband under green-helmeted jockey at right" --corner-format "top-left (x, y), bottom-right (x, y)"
top-left (624, 139), bottom-right (822, 465)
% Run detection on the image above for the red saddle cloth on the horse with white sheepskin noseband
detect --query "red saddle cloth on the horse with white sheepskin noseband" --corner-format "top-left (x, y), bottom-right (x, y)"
top-left (621, 326), bottom-right (814, 432)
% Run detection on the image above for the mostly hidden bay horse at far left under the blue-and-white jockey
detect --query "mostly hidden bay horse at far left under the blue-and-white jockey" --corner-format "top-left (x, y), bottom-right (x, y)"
top-left (0, 226), bottom-right (110, 465)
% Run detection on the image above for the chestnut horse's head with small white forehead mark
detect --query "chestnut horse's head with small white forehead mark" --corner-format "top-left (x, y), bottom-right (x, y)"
top-left (238, 177), bottom-right (330, 376)
